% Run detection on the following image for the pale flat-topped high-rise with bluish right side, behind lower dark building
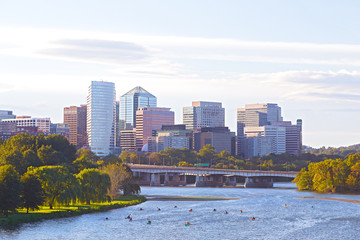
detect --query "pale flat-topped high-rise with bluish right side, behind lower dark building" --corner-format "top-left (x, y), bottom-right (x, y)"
top-left (183, 101), bottom-right (225, 130)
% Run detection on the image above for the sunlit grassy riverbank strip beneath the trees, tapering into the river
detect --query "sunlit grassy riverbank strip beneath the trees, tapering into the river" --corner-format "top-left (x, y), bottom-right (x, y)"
top-left (0, 196), bottom-right (146, 227)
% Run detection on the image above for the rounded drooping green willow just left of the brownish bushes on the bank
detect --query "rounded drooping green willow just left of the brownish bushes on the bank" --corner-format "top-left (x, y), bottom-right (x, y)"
top-left (76, 169), bottom-right (111, 204)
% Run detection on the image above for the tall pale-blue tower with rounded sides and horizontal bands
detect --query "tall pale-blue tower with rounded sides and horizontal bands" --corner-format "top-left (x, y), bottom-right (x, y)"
top-left (87, 81), bottom-right (116, 156)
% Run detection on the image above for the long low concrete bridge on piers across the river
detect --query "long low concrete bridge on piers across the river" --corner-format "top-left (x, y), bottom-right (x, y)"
top-left (127, 164), bottom-right (297, 188)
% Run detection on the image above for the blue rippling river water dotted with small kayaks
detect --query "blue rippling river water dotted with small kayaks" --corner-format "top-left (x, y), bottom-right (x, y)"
top-left (0, 184), bottom-right (360, 240)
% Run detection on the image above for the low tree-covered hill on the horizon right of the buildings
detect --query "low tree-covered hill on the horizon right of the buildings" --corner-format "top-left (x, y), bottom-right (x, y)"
top-left (303, 144), bottom-right (360, 157)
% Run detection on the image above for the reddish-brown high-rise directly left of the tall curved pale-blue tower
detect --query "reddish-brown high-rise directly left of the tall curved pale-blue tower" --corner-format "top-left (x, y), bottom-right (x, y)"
top-left (64, 105), bottom-right (87, 148)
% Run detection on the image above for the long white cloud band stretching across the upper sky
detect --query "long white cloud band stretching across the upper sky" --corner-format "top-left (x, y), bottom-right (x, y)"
top-left (0, 27), bottom-right (360, 66)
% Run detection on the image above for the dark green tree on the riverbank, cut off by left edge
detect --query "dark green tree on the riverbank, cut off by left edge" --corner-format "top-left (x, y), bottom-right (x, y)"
top-left (0, 165), bottom-right (22, 217)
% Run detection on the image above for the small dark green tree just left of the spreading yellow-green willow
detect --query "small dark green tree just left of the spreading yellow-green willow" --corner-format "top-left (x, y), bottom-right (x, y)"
top-left (21, 172), bottom-right (45, 213)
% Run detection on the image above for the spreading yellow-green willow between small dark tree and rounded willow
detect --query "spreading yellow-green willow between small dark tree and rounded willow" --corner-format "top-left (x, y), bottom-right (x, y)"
top-left (28, 166), bottom-right (76, 209)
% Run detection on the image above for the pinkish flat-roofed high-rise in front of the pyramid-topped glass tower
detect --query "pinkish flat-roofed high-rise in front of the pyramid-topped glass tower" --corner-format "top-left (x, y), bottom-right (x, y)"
top-left (136, 107), bottom-right (174, 151)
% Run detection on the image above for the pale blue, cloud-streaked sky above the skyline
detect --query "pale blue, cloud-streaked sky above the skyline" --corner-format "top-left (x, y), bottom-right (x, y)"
top-left (0, 0), bottom-right (360, 147)
